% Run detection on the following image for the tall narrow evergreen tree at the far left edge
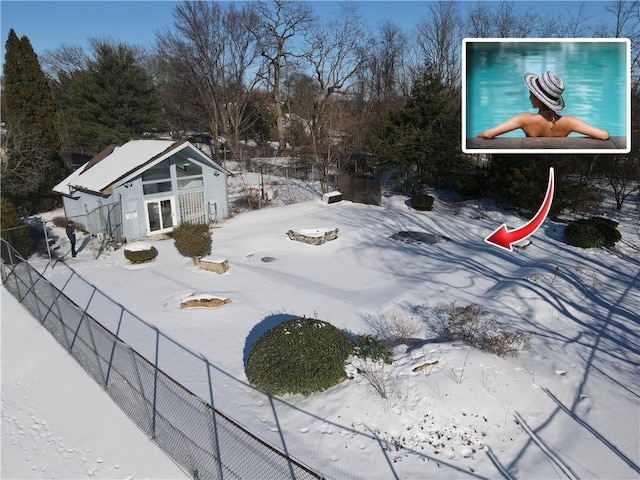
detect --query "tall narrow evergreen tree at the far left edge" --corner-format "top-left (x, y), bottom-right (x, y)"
top-left (2, 29), bottom-right (66, 213)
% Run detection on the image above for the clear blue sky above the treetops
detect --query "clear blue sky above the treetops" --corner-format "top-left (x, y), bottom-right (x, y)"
top-left (0, 0), bottom-right (616, 58)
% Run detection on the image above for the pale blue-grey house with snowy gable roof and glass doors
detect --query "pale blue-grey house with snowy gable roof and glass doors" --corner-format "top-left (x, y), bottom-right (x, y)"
top-left (53, 140), bottom-right (229, 242)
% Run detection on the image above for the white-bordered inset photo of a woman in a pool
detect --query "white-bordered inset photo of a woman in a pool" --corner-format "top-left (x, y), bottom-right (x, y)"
top-left (462, 38), bottom-right (631, 153)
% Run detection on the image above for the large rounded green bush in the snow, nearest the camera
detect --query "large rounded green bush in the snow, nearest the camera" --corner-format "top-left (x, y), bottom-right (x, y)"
top-left (247, 317), bottom-right (353, 395)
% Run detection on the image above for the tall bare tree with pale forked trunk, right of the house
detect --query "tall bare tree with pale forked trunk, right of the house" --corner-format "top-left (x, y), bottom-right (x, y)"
top-left (255, 0), bottom-right (313, 152)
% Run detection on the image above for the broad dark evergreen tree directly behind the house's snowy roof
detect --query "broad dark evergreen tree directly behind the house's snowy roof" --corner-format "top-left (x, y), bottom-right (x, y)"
top-left (58, 41), bottom-right (162, 153)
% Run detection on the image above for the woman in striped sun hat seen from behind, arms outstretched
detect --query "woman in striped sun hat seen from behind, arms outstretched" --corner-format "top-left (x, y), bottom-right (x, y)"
top-left (478, 72), bottom-right (609, 140)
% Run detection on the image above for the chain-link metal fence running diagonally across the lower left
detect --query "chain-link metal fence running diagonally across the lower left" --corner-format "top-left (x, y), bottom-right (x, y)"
top-left (0, 238), bottom-right (323, 479)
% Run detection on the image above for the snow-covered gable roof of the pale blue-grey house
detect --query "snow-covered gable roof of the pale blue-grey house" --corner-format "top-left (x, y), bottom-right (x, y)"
top-left (53, 140), bottom-right (224, 195)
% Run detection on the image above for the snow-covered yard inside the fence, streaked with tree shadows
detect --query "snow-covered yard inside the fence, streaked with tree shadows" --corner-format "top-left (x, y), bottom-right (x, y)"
top-left (3, 178), bottom-right (640, 479)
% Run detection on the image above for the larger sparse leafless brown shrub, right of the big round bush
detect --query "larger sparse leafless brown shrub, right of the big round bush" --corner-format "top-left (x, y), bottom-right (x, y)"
top-left (438, 303), bottom-right (531, 357)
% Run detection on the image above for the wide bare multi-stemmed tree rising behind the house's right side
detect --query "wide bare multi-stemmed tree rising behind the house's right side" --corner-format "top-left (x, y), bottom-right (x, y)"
top-left (157, 1), bottom-right (259, 160)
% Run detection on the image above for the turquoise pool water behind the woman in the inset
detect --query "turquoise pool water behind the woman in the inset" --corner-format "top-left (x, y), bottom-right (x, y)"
top-left (465, 41), bottom-right (628, 137)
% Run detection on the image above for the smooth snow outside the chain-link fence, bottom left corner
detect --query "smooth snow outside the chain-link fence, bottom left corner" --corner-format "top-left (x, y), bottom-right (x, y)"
top-left (0, 288), bottom-right (188, 480)
